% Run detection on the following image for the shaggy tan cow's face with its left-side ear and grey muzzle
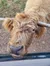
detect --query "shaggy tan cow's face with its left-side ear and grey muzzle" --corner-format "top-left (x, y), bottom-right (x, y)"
top-left (3, 14), bottom-right (35, 55)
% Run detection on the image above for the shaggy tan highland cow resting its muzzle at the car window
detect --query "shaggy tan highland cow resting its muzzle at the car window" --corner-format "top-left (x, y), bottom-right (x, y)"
top-left (3, 0), bottom-right (50, 57)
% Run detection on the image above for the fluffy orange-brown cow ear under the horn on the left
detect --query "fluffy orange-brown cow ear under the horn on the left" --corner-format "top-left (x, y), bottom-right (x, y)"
top-left (2, 18), bottom-right (13, 32)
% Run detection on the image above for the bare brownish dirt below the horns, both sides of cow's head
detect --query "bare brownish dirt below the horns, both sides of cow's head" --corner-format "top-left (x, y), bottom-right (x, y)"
top-left (0, 22), bottom-right (50, 54)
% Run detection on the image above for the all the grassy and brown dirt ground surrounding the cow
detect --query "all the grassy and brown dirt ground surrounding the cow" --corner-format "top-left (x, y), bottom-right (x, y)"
top-left (0, 0), bottom-right (50, 54)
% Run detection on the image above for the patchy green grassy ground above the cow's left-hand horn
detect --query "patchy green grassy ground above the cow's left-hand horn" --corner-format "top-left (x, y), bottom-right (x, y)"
top-left (0, 0), bottom-right (26, 17)
